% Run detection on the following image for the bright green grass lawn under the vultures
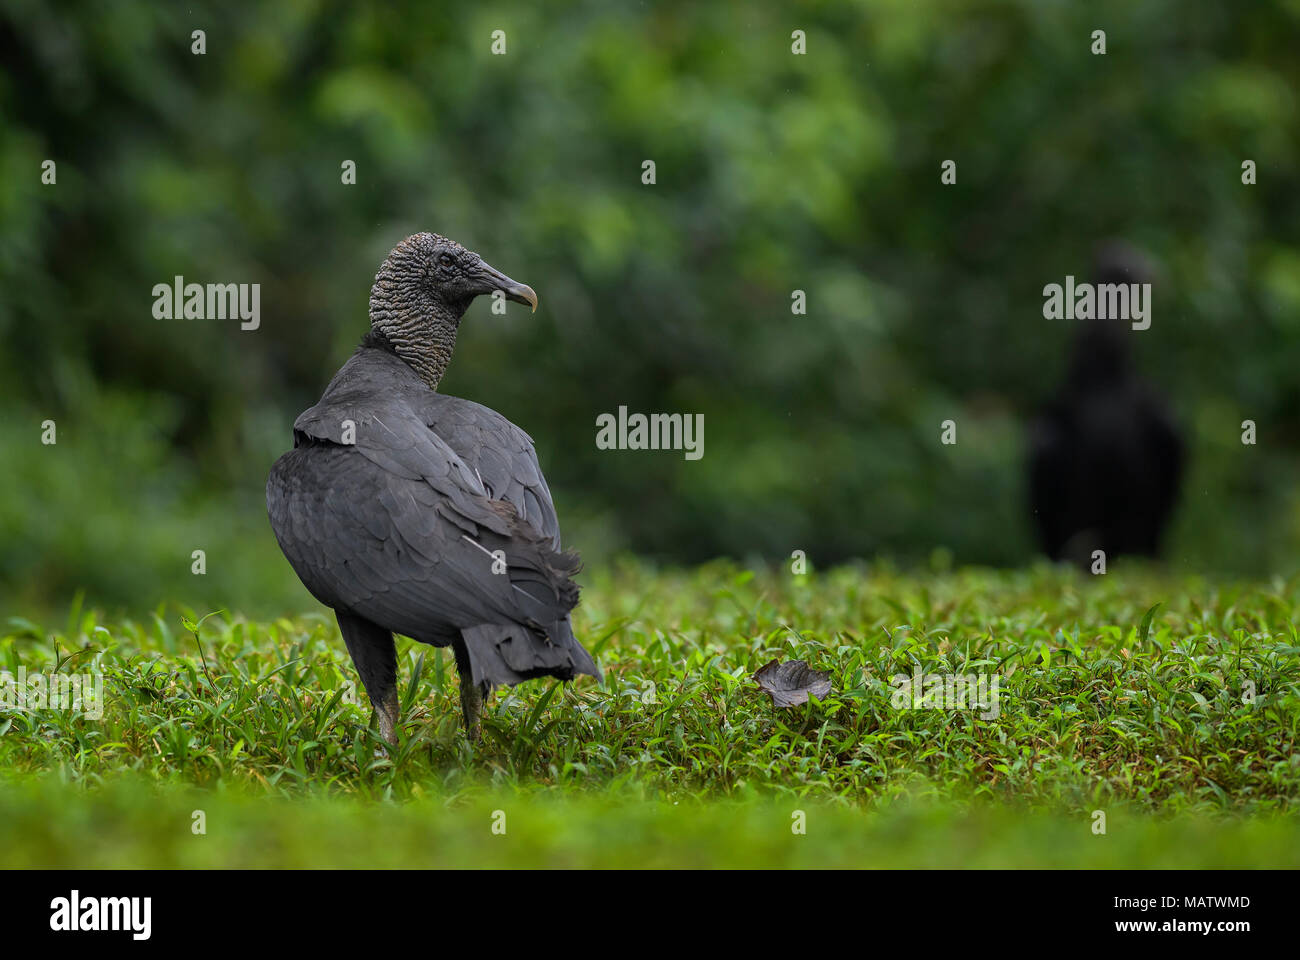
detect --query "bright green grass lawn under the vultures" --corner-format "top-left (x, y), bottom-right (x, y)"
top-left (0, 565), bottom-right (1300, 866)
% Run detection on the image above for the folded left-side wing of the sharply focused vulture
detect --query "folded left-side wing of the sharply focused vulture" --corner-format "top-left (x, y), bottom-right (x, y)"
top-left (268, 445), bottom-right (577, 643)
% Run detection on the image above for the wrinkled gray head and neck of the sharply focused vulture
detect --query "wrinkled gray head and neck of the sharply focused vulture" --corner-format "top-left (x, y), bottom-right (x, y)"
top-left (371, 233), bottom-right (537, 389)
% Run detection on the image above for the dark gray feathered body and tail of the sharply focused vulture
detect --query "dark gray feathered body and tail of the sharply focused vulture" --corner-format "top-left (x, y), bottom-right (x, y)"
top-left (267, 351), bottom-right (594, 682)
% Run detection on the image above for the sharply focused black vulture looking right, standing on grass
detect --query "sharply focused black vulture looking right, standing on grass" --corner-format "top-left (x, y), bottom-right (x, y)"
top-left (267, 233), bottom-right (601, 744)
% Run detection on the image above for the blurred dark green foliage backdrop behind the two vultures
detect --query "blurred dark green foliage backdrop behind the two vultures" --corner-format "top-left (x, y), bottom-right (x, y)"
top-left (0, 0), bottom-right (1300, 610)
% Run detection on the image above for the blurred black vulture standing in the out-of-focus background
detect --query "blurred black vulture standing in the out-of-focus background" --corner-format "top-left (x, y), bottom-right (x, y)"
top-left (1028, 243), bottom-right (1184, 567)
